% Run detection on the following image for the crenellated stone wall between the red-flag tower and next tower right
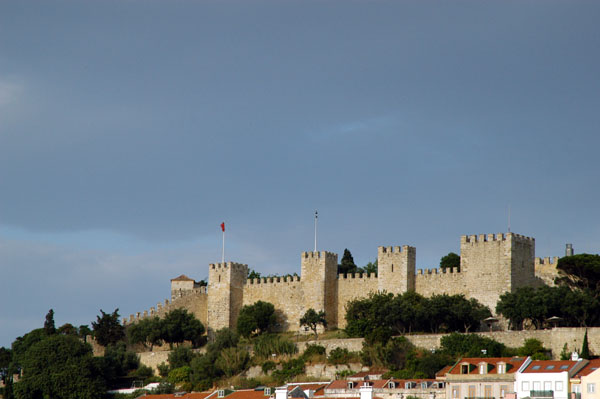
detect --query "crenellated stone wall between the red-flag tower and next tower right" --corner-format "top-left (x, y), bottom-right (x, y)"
top-left (243, 276), bottom-right (305, 331)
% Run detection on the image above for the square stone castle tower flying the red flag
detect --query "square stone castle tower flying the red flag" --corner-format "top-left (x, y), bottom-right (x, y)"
top-left (207, 262), bottom-right (248, 332)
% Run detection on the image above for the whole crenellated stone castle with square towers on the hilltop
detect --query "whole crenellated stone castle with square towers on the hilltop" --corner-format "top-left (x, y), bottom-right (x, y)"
top-left (124, 233), bottom-right (558, 332)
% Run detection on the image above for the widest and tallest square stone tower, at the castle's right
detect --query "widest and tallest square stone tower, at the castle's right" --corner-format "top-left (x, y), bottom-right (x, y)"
top-left (460, 233), bottom-right (538, 313)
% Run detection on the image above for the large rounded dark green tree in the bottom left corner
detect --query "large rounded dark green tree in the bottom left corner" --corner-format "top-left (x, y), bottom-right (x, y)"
top-left (14, 335), bottom-right (106, 399)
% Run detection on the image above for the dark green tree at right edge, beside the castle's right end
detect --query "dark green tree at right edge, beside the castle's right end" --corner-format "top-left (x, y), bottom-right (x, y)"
top-left (556, 254), bottom-right (600, 298)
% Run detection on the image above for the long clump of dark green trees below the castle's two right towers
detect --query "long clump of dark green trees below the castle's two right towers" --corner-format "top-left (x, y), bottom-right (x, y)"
top-left (346, 291), bottom-right (491, 341)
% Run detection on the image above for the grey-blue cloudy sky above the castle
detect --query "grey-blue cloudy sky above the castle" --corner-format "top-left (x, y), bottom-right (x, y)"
top-left (0, 0), bottom-right (600, 346)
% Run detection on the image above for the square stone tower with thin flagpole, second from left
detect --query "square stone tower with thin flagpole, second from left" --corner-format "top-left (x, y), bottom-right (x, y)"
top-left (300, 251), bottom-right (337, 327)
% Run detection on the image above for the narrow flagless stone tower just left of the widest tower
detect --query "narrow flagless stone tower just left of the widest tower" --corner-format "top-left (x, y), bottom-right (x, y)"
top-left (377, 245), bottom-right (417, 294)
